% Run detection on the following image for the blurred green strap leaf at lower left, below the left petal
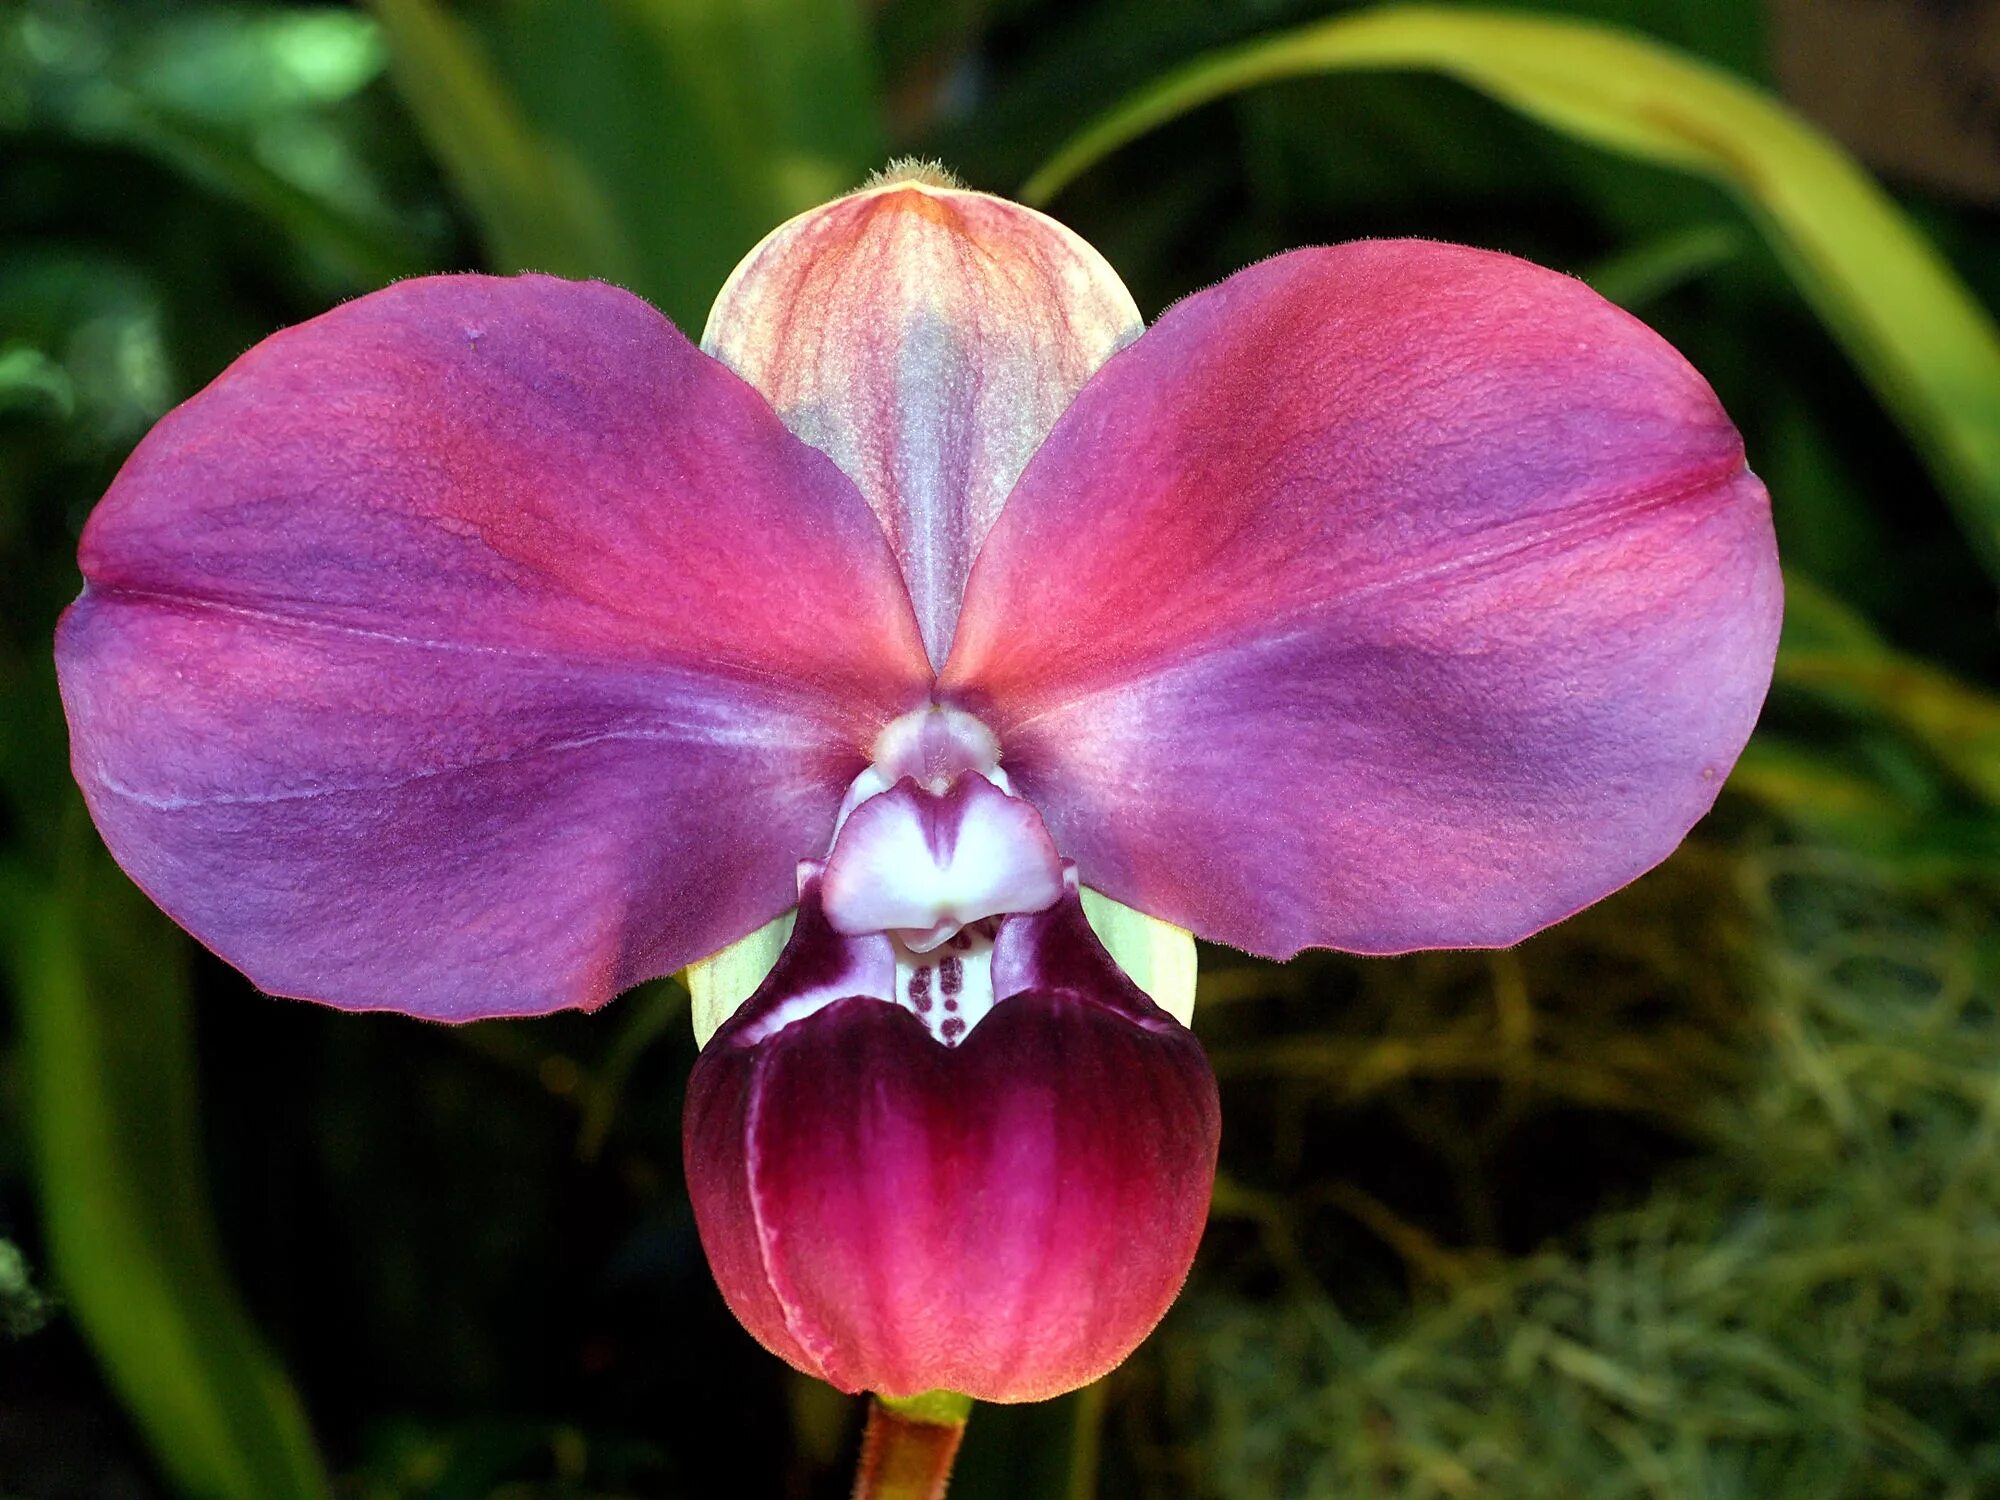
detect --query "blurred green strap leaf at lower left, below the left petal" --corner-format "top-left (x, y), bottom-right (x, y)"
top-left (0, 836), bottom-right (328, 1500)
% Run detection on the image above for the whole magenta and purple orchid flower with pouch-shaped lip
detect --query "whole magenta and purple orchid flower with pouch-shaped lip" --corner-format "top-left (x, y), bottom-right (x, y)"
top-left (56, 174), bottom-right (1780, 1424)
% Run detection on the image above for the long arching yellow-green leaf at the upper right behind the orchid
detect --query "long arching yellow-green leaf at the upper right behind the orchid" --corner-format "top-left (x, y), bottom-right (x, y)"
top-left (1022, 6), bottom-right (2000, 576)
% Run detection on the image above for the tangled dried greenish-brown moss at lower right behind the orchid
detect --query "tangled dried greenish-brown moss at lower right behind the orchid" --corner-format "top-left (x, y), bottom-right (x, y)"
top-left (1122, 848), bottom-right (2000, 1500)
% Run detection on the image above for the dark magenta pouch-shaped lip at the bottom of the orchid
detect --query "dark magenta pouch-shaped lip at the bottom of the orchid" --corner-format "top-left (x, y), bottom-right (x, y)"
top-left (682, 888), bottom-right (1220, 1402)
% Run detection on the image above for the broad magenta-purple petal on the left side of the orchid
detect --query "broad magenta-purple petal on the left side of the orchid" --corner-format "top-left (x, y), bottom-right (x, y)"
top-left (56, 276), bottom-right (928, 1020)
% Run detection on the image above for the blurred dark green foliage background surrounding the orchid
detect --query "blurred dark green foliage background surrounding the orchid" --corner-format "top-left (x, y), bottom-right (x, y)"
top-left (0, 0), bottom-right (2000, 1500)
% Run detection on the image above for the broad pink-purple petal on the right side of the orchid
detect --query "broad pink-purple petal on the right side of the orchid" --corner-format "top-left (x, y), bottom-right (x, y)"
top-left (944, 242), bottom-right (1780, 954)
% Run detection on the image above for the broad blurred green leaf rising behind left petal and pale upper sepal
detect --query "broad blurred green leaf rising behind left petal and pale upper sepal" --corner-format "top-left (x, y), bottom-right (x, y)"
top-left (374, 0), bottom-right (882, 330)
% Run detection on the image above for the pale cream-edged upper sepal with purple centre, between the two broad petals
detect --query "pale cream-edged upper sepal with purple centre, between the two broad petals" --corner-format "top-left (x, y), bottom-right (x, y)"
top-left (702, 182), bottom-right (1140, 662)
